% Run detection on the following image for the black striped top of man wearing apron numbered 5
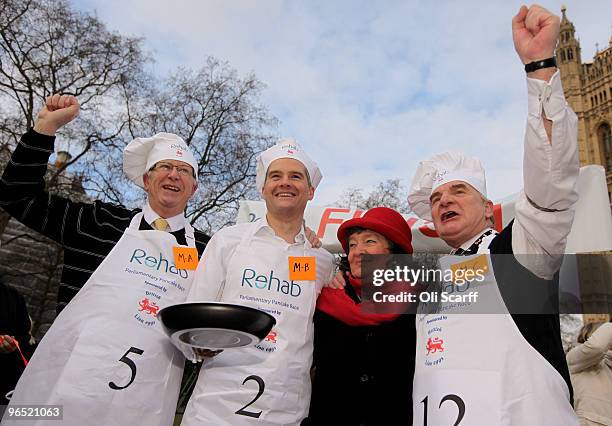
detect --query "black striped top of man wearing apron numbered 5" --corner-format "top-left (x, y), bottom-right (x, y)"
top-left (0, 130), bottom-right (210, 313)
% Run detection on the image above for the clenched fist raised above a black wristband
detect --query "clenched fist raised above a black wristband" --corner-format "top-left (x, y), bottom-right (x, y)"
top-left (512, 4), bottom-right (560, 64)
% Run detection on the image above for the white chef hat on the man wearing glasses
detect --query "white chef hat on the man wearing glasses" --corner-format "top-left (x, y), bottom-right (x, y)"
top-left (123, 133), bottom-right (198, 188)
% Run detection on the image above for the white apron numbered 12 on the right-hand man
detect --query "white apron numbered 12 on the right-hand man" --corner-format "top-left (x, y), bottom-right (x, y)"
top-left (412, 251), bottom-right (578, 426)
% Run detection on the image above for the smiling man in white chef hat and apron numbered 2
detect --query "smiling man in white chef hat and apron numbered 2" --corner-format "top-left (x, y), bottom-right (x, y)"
top-left (182, 139), bottom-right (333, 425)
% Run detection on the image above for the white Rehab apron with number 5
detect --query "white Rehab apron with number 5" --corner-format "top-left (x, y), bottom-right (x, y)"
top-left (2, 213), bottom-right (195, 426)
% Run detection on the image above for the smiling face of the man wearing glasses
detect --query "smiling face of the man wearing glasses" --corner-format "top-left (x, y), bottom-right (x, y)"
top-left (143, 160), bottom-right (198, 218)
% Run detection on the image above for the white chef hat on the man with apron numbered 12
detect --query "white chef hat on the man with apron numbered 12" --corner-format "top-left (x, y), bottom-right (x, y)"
top-left (408, 152), bottom-right (487, 220)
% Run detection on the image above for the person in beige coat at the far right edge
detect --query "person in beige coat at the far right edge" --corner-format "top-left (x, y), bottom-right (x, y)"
top-left (567, 322), bottom-right (612, 426)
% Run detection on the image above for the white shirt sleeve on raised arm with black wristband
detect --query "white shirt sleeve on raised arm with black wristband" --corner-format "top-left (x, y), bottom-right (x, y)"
top-left (512, 71), bottom-right (580, 279)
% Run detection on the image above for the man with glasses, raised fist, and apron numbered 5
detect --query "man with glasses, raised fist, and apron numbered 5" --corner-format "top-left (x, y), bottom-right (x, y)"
top-left (0, 95), bottom-right (208, 426)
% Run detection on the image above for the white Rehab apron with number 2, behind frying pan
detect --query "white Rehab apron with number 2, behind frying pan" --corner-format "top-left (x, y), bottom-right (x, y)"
top-left (181, 228), bottom-right (331, 426)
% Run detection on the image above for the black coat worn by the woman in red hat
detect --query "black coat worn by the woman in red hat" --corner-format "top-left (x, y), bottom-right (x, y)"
top-left (304, 302), bottom-right (416, 425)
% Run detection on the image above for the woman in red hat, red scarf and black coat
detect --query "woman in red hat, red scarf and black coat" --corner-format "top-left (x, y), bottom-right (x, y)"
top-left (308, 207), bottom-right (416, 425)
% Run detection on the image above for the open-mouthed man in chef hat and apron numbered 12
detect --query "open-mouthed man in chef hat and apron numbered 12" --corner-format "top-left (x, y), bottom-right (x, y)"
top-left (408, 5), bottom-right (579, 425)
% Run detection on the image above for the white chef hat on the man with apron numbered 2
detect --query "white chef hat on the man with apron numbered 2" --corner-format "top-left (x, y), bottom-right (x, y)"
top-left (255, 139), bottom-right (323, 193)
